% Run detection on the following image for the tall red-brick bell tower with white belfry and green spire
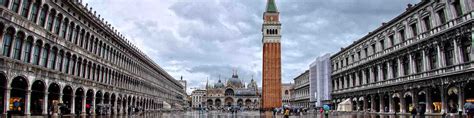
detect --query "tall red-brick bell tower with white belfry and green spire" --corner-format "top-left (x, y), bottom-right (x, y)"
top-left (262, 0), bottom-right (282, 110)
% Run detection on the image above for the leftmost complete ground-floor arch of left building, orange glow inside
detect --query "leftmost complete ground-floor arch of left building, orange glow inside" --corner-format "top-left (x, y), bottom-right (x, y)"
top-left (8, 77), bottom-right (28, 115)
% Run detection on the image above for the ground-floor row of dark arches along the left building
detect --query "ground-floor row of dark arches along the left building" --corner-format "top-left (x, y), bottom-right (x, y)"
top-left (0, 72), bottom-right (163, 115)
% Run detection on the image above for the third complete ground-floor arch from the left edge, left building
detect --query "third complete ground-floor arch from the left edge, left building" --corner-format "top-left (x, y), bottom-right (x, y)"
top-left (47, 83), bottom-right (61, 113)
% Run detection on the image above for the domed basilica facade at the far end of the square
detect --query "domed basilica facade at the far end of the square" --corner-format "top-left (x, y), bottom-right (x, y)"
top-left (203, 74), bottom-right (261, 110)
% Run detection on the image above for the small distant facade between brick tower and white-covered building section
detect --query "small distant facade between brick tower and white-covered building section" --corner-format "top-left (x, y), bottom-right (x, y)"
top-left (291, 70), bottom-right (310, 108)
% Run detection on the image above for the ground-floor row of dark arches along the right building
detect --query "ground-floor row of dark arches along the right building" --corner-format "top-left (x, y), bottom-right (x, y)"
top-left (333, 81), bottom-right (474, 114)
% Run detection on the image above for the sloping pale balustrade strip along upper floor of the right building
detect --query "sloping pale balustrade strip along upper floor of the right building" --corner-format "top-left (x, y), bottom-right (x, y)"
top-left (332, 12), bottom-right (474, 75)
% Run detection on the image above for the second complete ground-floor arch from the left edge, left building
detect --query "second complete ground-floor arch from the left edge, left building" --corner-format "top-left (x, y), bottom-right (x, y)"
top-left (30, 80), bottom-right (46, 115)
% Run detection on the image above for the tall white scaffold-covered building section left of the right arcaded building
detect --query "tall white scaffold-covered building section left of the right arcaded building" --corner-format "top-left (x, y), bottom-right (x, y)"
top-left (309, 54), bottom-right (332, 107)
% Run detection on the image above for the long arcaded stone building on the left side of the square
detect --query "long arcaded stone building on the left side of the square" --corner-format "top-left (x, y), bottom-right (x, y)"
top-left (0, 0), bottom-right (185, 115)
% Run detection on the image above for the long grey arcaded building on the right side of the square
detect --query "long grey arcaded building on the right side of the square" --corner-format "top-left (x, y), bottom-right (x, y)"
top-left (331, 0), bottom-right (474, 114)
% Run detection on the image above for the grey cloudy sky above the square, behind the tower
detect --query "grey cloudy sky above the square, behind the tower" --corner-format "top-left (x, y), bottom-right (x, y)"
top-left (84, 0), bottom-right (419, 93)
